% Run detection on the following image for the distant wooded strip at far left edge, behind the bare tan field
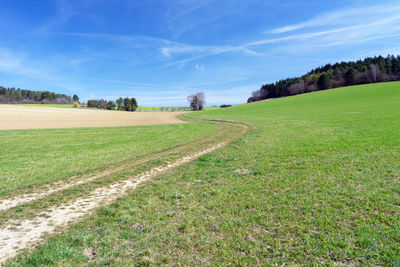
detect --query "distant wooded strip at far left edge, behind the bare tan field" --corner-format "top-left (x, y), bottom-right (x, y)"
top-left (0, 86), bottom-right (79, 104)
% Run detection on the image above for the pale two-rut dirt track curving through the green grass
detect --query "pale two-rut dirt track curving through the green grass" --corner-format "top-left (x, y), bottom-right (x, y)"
top-left (0, 120), bottom-right (250, 264)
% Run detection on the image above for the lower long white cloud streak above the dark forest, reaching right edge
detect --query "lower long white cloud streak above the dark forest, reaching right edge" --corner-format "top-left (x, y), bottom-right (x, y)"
top-left (162, 13), bottom-right (400, 67)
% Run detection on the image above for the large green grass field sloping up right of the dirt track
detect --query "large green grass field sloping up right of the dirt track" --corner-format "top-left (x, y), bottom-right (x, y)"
top-left (2, 82), bottom-right (400, 266)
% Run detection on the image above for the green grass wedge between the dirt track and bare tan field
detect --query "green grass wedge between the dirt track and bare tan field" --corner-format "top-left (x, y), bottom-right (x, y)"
top-left (0, 123), bottom-right (216, 195)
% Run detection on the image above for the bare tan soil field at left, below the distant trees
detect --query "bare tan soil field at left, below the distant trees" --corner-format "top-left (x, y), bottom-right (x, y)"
top-left (0, 105), bottom-right (184, 130)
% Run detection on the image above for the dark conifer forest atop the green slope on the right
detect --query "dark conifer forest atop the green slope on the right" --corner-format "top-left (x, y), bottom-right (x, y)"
top-left (247, 55), bottom-right (400, 103)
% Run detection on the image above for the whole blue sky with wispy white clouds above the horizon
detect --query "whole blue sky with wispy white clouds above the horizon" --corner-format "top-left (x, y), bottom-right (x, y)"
top-left (0, 0), bottom-right (400, 106)
